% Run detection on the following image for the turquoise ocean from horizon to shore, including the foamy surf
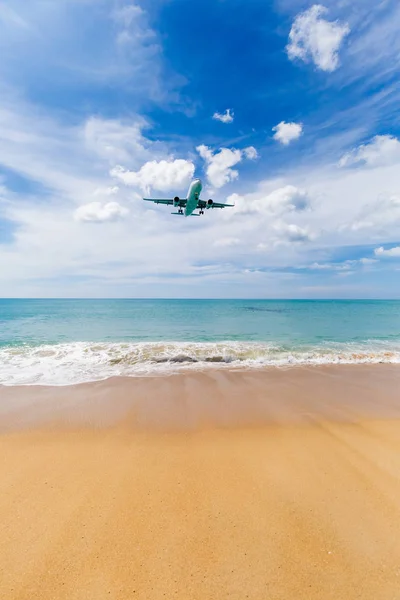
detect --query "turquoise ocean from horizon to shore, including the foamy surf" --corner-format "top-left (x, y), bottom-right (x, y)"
top-left (0, 299), bottom-right (400, 385)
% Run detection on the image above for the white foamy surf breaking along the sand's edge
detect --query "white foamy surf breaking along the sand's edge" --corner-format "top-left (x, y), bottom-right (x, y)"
top-left (0, 341), bottom-right (400, 386)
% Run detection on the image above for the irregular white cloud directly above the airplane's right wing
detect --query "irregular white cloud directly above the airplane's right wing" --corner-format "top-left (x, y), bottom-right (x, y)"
top-left (196, 144), bottom-right (257, 189)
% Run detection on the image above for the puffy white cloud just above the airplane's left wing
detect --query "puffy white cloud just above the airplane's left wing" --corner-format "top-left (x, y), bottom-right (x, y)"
top-left (110, 158), bottom-right (195, 192)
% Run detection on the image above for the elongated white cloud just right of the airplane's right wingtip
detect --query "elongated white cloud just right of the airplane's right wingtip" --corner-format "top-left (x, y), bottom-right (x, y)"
top-left (228, 185), bottom-right (310, 215)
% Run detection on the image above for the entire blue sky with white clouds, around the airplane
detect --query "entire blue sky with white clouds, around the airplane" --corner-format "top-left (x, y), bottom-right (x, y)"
top-left (0, 0), bottom-right (400, 298)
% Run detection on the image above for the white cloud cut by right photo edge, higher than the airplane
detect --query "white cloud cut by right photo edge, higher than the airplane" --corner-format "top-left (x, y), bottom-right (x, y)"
top-left (339, 135), bottom-right (400, 167)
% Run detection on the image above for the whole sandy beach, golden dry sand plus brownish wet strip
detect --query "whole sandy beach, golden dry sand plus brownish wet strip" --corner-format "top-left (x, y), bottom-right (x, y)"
top-left (0, 365), bottom-right (400, 600)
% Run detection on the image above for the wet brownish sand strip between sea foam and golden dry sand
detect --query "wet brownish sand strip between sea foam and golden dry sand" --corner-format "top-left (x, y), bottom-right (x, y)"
top-left (0, 364), bottom-right (400, 433)
